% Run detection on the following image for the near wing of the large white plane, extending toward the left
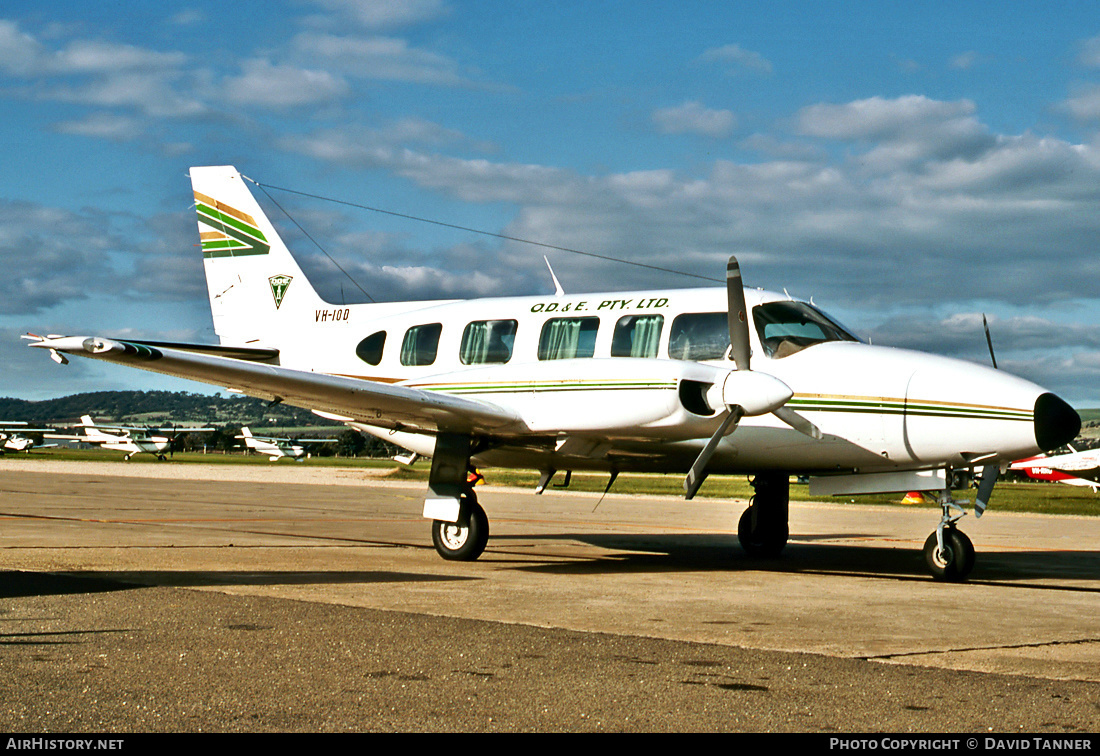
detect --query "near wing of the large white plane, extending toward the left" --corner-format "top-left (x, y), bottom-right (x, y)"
top-left (31, 336), bottom-right (524, 434)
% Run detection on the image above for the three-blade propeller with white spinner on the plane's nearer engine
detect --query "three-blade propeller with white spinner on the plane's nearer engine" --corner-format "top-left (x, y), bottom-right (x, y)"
top-left (684, 256), bottom-right (822, 498)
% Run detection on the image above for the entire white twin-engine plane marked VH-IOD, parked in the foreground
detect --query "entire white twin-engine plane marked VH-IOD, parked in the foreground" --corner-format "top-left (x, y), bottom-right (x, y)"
top-left (32, 166), bottom-right (1080, 580)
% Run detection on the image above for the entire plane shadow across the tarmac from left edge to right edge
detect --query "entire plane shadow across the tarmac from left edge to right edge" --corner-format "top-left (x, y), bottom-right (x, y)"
top-left (0, 541), bottom-right (1100, 599)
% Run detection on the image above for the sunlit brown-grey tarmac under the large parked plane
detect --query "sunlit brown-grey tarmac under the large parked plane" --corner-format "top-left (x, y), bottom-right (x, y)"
top-left (0, 458), bottom-right (1100, 735)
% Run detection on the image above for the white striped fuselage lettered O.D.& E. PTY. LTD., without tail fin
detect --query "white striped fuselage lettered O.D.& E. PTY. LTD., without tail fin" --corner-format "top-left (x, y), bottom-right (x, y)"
top-left (255, 288), bottom-right (1076, 473)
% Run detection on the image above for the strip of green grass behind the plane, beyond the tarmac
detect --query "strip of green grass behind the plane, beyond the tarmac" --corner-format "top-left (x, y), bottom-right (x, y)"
top-left (6, 449), bottom-right (1100, 516)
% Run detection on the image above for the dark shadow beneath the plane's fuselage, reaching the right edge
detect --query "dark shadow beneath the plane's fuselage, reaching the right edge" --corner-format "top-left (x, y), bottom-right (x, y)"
top-left (499, 533), bottom-right (1100, 593)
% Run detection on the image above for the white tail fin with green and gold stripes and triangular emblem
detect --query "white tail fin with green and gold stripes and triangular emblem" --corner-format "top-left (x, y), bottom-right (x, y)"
top-left (190, 165), bottom-right (326, 347)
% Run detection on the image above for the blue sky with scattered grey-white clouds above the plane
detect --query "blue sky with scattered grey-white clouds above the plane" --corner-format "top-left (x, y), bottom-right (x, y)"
top-left (0, 0), bottom-right (1100, 407)
